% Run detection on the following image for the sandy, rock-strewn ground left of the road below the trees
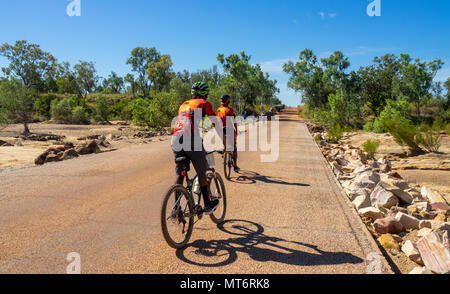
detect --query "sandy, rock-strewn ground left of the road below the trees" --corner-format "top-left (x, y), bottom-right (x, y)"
top-left (0, 124), bottom-right (170, 171)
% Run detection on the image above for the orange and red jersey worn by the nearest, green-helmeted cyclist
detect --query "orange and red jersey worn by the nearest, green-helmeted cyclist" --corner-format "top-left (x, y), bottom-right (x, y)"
top-left (173, 98), bottom-right (215, 136)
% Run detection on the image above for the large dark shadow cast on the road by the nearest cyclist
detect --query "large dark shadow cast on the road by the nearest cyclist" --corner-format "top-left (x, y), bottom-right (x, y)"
top-left (176, 220), bottom-right (363, 267)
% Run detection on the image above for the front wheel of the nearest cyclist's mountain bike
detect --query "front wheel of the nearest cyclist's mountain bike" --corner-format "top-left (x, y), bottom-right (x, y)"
top-left (206, 171), bottom-right (227, 224)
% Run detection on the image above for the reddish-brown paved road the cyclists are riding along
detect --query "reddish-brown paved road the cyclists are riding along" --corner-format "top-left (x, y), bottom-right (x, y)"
top-left (0, 111), bottom-right (390, 273)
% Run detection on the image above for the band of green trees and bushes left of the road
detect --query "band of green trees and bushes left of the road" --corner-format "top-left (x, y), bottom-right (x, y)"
top-left (0, 41), bottom-right (281, 132)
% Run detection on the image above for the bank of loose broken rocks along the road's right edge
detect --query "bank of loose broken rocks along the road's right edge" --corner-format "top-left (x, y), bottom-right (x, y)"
top-left (307, 123), bottom-right (450, 274)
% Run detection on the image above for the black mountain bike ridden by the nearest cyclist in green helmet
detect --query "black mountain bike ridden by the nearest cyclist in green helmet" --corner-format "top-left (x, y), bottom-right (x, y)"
top-left (161, 151), bottom-right (227, 249)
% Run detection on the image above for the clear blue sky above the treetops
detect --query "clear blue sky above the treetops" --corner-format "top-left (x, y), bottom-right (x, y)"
top-left (0, 0), bottom-right (450, 105)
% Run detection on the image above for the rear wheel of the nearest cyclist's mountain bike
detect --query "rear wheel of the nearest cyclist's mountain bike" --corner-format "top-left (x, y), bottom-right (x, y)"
top-left (161, 185), bottom-right (194, 249)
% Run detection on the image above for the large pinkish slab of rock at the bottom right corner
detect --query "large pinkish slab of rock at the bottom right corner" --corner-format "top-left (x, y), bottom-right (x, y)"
top-left (417, 232), bottom-right (450, 274)
